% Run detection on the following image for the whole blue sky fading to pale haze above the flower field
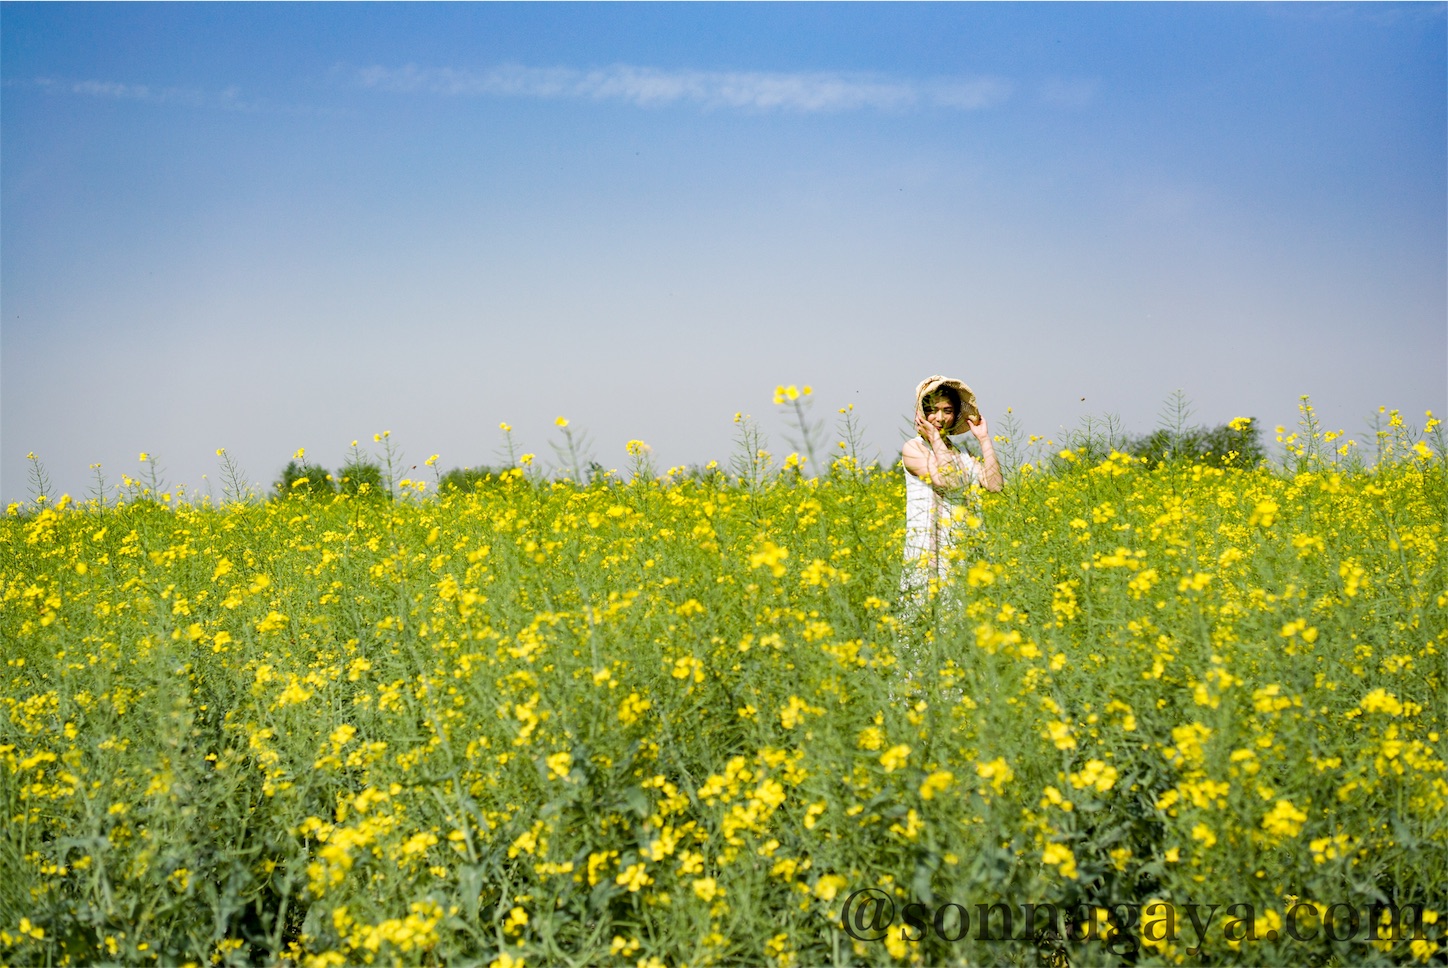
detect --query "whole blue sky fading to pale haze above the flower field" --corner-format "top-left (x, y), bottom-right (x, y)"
top-left (0, 3), bottom-right (1448, 501)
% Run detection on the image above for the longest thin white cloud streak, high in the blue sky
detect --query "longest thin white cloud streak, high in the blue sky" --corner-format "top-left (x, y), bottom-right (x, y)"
top-left (355, 64), bottom-right (1011, 113)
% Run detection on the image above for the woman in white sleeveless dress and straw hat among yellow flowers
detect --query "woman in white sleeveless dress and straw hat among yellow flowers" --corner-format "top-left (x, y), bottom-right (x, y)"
top-left (901, 376), bottom-right (1002, 596)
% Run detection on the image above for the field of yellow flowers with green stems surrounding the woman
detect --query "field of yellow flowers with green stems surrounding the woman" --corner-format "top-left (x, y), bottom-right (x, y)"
top-left (0, 408), bottom-right (1448, 967)
